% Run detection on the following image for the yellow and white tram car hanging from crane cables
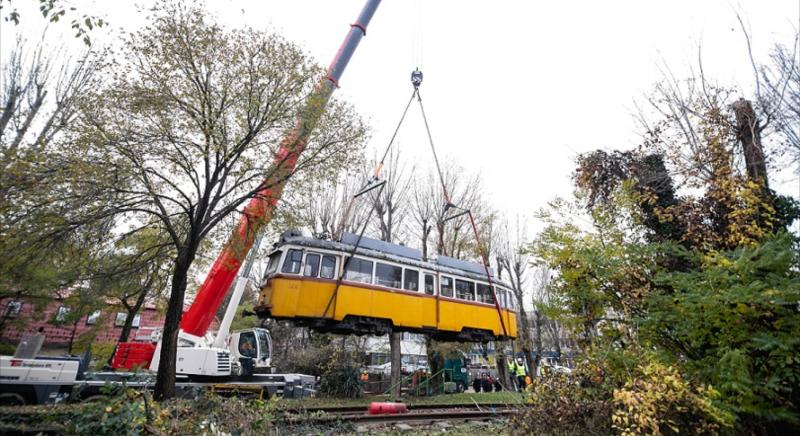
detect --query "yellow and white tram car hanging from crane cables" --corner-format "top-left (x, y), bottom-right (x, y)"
top-left (255, 231), bottom-right (517, 342)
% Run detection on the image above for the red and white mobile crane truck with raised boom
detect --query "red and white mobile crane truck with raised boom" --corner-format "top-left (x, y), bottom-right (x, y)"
top-left (0, 0), bottom-right (380, 404)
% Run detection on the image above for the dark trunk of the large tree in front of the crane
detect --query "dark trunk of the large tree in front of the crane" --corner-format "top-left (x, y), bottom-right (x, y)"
top-left (153, 248), bottom-right (191, 401)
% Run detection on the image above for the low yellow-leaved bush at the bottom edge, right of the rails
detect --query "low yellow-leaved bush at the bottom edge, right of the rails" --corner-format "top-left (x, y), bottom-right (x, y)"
top-left (512, 349), bottom-right (733, 435)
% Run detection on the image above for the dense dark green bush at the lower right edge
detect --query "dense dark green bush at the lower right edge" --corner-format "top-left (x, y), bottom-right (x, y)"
top-left (640, 234), bottom-right (800, 432)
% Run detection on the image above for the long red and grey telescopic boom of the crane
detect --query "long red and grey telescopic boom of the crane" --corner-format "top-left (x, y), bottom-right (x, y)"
top-left (181, 0), bottom-right (380, 336)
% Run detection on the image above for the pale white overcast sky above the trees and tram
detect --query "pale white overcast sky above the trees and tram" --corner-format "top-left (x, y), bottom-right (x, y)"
top-left (0, 0), bottom-right (800, 235)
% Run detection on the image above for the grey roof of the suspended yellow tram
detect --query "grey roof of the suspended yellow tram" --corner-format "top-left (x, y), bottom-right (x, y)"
top-left (275, 232), bottom-right (509, 287)
